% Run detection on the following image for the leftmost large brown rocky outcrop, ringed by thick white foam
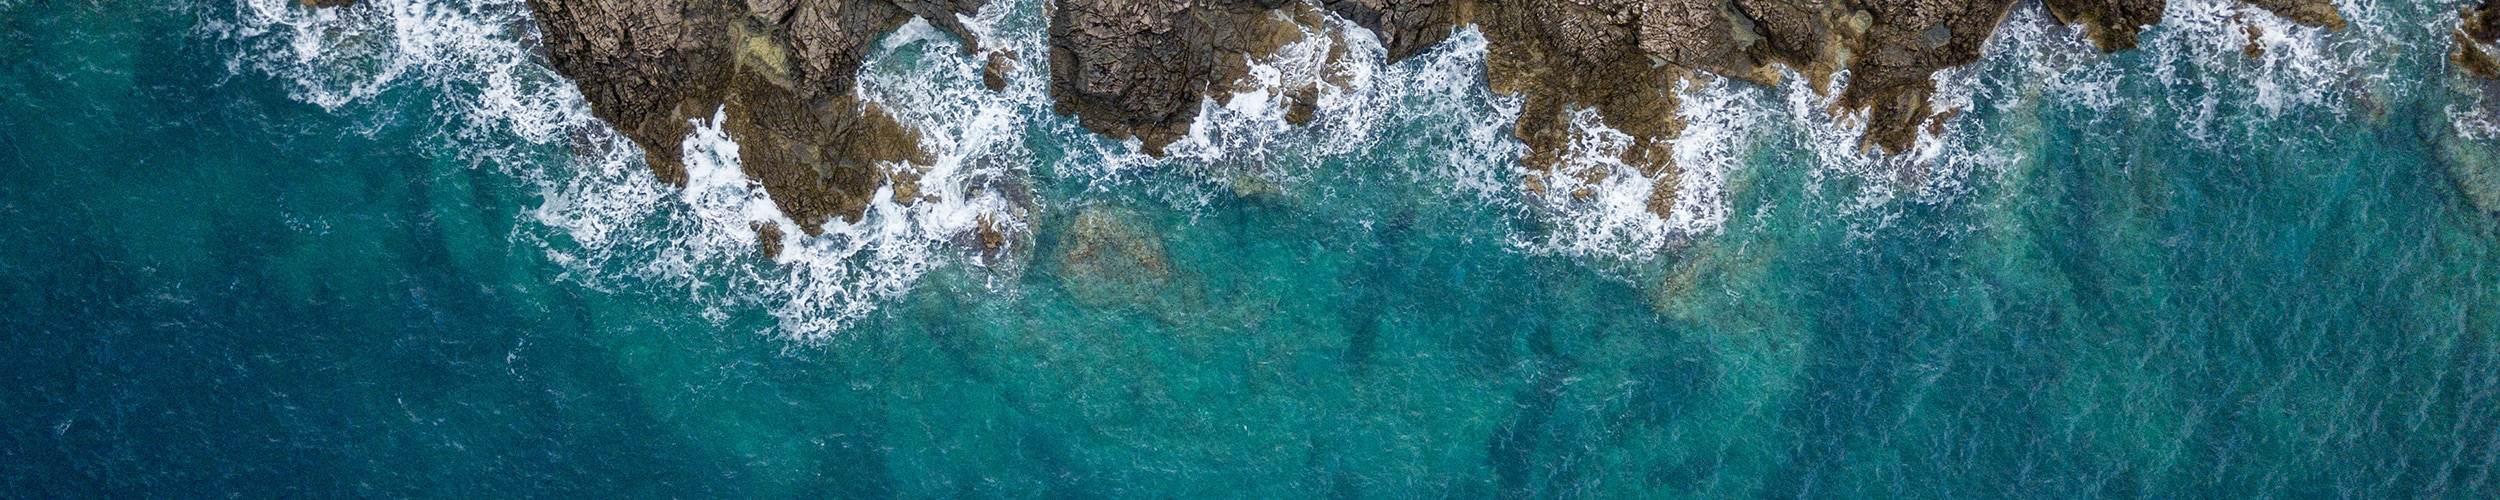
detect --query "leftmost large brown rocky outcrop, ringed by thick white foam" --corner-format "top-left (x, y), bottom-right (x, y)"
top-left (530, 0), bottom-right (980, 233)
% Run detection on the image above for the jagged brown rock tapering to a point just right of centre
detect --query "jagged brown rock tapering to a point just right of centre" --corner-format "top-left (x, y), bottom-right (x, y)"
top-left (1328, 0), bottom-right (1770, 215)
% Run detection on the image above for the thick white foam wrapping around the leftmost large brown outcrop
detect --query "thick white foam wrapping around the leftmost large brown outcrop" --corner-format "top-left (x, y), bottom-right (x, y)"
top-left (203, 0), bottom-right (1048, 343)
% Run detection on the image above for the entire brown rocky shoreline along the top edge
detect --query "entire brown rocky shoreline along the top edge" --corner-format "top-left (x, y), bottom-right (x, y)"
top-left (303, 0), bottom-right (2350, 233)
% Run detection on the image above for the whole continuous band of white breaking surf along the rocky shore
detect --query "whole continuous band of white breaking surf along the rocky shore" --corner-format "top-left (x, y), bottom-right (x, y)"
top-left (200, 0), bottom-right (2440, 343)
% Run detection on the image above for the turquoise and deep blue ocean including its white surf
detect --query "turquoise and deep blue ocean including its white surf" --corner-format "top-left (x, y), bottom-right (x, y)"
top-left (14, 0), bottom-right (2500, 498)
